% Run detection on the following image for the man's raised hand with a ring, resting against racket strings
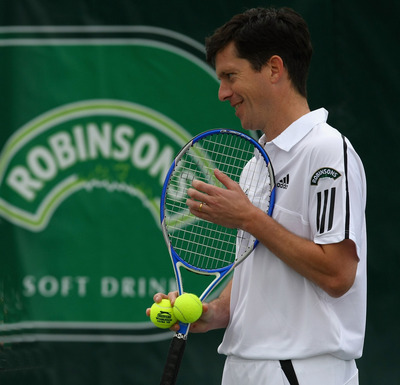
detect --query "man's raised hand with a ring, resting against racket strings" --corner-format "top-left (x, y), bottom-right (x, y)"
top-left (186, 169), bottom-right (254, 229)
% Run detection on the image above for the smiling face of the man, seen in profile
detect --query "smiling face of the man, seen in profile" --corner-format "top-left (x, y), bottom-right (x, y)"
top-left (215, 43), bottom-right (271, 131)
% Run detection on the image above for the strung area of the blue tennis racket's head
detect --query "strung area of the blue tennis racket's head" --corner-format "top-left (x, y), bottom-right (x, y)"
top-left (165, 134), bottom-right (270, 270)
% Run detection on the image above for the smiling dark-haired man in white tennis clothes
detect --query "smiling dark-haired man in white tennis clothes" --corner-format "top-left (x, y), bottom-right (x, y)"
top-left (147, 8), bottom-right (366, 385)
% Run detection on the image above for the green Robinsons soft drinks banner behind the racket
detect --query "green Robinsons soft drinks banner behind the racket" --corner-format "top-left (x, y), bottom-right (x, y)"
top-left (0, 26), bottom-right (239, 342)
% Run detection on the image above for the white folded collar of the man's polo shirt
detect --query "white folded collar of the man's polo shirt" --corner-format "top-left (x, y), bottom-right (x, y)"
top-left (259, 108), bottom-right (328, 151)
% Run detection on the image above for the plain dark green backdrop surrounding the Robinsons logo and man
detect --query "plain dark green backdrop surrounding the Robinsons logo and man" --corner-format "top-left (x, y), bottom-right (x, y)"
top-left (0, 0), bottom-right (400, 385)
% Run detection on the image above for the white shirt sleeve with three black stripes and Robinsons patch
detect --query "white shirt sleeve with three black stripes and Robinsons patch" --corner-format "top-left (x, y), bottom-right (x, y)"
top-left (309, 136), bottom-right (365, 244)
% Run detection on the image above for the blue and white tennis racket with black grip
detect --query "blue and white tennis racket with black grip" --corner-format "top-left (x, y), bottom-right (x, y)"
top-left (160, 129), bottom-right (275, 385)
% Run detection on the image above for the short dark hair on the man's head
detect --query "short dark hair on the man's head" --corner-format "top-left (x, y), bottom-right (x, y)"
top-left (206, 7), bottom-right (312, 97)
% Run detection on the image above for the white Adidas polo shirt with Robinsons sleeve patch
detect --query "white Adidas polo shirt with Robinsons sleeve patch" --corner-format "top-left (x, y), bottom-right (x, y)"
top-left (218, 109), bottom-right (366, 360)
